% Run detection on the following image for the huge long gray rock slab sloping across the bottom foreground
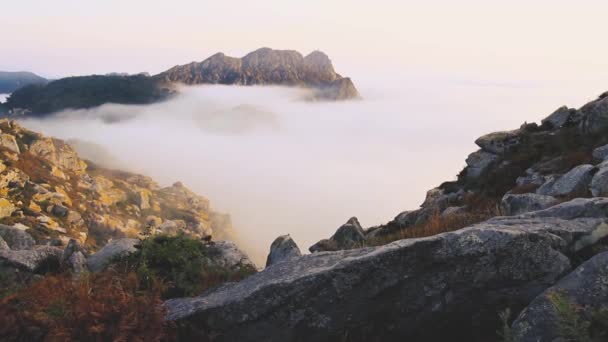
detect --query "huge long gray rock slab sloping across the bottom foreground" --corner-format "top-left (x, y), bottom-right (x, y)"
top-left (165, 221), bottom-right (582, 341)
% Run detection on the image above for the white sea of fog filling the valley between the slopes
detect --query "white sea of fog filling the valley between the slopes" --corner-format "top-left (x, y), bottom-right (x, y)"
top-left (23, 78), bottom-right (604, 265)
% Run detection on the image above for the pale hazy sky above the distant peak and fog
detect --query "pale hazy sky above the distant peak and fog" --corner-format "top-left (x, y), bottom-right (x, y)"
top-left (0, 0), bottom-right (608, 82)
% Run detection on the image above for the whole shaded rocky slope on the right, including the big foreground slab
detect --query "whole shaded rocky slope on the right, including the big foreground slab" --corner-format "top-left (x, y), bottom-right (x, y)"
top-left (165, 94), bottom-right (608, 342)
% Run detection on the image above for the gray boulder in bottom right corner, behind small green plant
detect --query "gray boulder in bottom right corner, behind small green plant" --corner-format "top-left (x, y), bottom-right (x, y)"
top-left (512, 252), bottom-right (608, 342)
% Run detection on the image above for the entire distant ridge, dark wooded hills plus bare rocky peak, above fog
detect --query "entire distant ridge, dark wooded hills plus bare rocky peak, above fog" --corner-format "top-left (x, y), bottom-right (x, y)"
top-left (0, 48), bottom-right (359, 117)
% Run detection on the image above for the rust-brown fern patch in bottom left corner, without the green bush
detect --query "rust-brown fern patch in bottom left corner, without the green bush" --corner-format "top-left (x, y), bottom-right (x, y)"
top-left (0, 270), bottom-right (167, 341)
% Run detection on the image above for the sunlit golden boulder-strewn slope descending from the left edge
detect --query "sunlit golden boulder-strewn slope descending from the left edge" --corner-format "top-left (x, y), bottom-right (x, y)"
top-left (0, 119), bottom-right (233, 250)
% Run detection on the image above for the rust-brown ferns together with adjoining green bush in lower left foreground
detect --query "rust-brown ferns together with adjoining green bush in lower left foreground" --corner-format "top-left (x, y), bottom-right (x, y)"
top-left (0, 235), bottom-right (255, 341)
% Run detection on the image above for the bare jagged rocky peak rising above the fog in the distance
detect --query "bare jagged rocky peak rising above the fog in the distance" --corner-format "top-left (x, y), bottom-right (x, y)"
top-left (156, 48), bottom-right (359, 100)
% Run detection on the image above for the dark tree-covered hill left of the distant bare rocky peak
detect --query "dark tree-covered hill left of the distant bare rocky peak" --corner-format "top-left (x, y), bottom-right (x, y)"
top-left (6, 75), bottom-right (172, 116)
